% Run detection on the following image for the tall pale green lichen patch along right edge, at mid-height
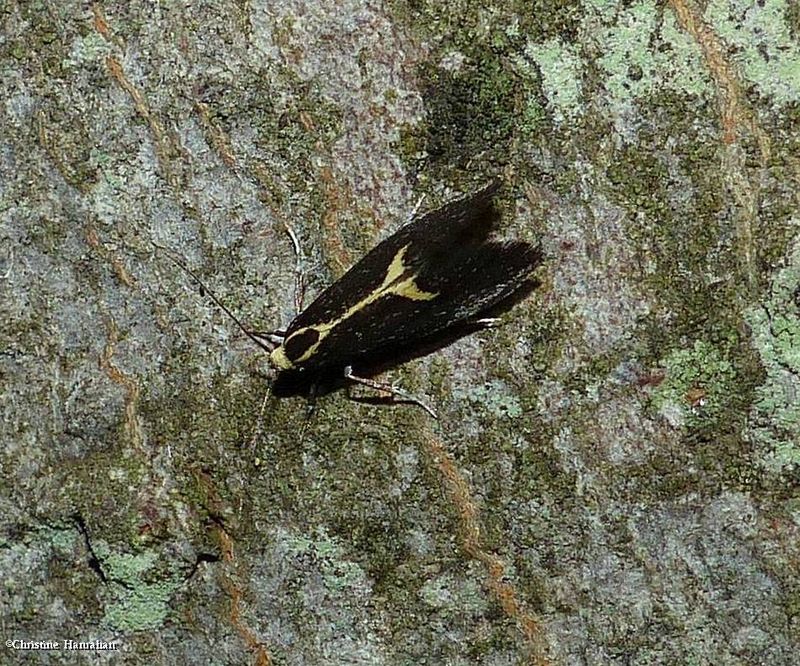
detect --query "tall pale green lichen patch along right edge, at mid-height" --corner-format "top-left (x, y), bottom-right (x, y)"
top-left (746, 235), bottom-right (800, 473)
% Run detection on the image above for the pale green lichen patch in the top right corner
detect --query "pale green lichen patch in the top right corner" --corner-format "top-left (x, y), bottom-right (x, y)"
top-left (705, 0), bottom-right (800, 104)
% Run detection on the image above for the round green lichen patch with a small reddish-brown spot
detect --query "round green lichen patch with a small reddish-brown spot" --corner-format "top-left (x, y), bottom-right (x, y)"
top-left (651, 340), bottom-right (736, 426)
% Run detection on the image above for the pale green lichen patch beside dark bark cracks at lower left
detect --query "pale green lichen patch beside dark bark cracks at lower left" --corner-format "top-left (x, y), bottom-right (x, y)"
top-left (93, 541), bottom-right (181, 631)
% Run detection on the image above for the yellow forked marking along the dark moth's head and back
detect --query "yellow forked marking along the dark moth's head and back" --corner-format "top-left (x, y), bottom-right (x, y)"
top-left (269, 245), bottom-right (439, 370)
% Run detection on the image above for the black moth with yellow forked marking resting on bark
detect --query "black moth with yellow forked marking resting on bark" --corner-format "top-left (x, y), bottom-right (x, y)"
top-left (159, 181), bottom-right (542, 416)
